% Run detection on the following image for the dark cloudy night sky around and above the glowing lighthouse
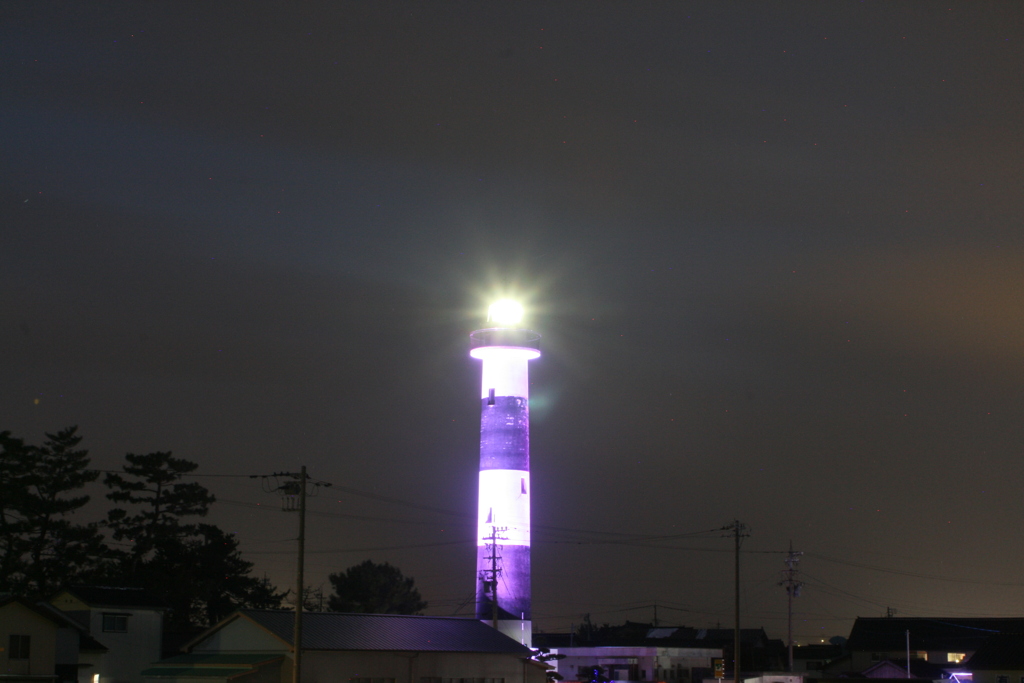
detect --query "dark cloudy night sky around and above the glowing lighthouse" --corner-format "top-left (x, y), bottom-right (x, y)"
top-left (0, 1), bottom-right (1024, 642)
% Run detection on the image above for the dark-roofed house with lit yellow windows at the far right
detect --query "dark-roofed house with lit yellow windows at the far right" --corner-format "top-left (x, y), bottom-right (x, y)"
top-left (824, 616), bottom-right (1024, 683)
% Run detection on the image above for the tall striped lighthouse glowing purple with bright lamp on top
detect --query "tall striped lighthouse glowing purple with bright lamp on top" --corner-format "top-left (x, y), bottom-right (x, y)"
top-left (470, 301), bottom-right (541, 646)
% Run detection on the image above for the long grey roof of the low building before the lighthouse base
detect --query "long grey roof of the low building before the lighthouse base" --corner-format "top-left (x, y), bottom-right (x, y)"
top-left (240, 609), bottom-right (529, 656)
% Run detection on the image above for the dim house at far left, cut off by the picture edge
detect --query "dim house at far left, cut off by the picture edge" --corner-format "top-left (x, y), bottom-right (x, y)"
top-left (0, 596), bottom-right (105, 683)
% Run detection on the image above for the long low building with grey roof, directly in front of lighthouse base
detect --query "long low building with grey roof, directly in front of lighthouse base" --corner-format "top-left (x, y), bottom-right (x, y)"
top-left (142, 609), bottom-right (547, 683)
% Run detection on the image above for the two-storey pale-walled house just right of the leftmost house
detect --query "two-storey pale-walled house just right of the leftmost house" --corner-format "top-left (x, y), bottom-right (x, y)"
top-left (50, 586), bottom-right (164, 683)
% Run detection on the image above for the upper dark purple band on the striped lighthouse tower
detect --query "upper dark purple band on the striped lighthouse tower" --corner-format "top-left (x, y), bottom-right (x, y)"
top-left (480, 396), bottom-right (529, 470)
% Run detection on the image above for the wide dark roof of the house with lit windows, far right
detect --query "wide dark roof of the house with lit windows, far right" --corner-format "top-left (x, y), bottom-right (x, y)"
top-left (847, 616), bottom-right (1024, 652)
